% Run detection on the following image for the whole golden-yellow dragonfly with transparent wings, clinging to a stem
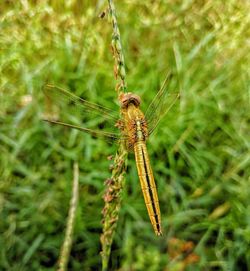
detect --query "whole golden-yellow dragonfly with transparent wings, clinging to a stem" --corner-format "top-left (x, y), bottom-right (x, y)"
top-left (43, 74), bottom-right (180, 236)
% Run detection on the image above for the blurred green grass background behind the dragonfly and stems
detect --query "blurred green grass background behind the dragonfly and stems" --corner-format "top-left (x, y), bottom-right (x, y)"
top-left (0, 0), bottom-right (250, 271)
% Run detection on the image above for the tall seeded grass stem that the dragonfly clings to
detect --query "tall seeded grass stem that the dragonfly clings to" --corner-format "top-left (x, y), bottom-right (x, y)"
top-left (101, 0), bottom-right (127, 271)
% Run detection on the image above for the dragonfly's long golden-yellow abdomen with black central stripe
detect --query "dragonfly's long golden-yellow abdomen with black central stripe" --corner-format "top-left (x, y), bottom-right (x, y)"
top-left (134, 141), bottom-right (162, 235)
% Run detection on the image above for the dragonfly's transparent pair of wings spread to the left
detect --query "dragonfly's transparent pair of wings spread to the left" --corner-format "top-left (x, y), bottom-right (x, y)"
top-left (43, 85), bottom-right (125, 140)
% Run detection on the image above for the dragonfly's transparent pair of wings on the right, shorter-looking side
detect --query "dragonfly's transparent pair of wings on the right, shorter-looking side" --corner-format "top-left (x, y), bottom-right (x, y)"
top-left (145, 73), bottom-right (180, 134)
